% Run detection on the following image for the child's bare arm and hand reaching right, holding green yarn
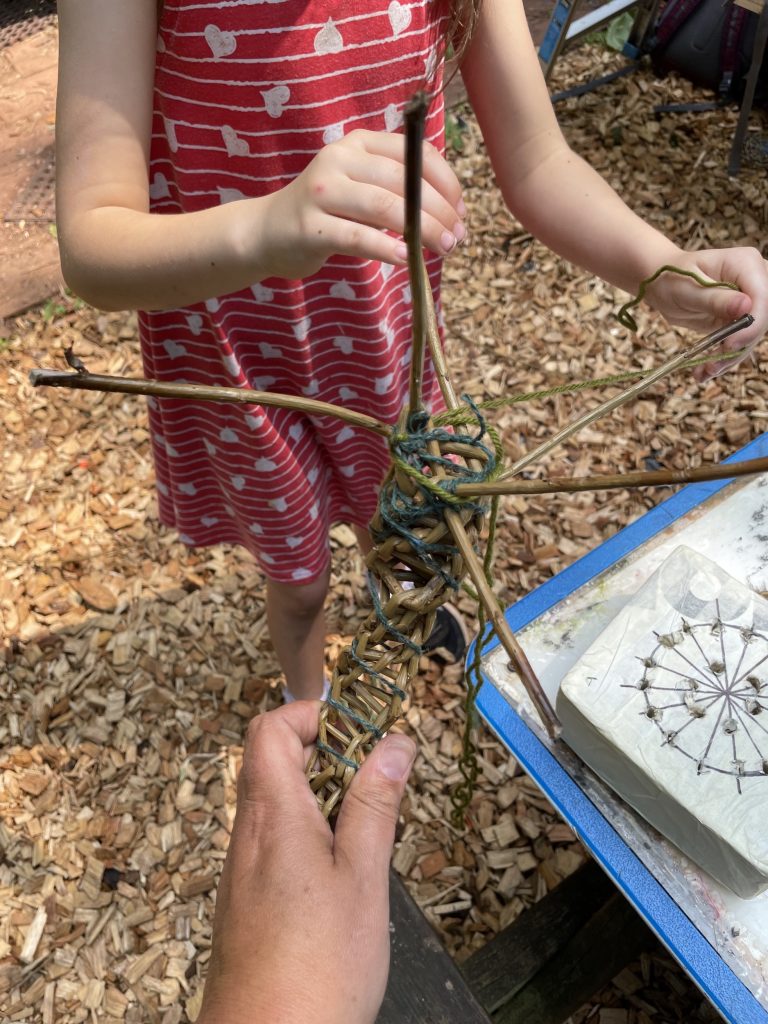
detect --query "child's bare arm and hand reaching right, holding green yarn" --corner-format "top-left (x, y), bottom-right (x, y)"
top-left (462, 0), bottom-right (768, 368)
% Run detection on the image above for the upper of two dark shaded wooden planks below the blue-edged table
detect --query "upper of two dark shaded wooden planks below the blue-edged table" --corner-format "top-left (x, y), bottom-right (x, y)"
top-left (462, 860), bottom-right (615, 1024)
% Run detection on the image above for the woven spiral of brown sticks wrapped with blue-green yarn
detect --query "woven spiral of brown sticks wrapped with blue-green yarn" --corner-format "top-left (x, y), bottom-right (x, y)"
top-left (307, 411), bottom-right (499, 817)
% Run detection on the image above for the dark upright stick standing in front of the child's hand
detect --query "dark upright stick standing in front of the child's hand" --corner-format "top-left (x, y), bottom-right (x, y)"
top-left (404, 92), bottom-right (427, 423)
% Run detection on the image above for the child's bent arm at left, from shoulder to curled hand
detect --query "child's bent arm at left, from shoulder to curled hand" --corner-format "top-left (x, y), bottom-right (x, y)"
top-left (56, 0), bottom-right (463, 309)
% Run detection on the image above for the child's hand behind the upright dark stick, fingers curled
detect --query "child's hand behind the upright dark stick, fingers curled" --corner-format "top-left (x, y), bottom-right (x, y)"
top-left (260, 130), bottom-right (465, 279)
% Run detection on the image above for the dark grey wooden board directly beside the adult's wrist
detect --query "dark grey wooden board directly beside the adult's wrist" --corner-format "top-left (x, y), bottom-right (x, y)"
top-left (377, 871), bottom-right (490, 1024)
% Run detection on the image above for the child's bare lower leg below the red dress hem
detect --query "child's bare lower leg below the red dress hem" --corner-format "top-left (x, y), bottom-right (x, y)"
top-left (266, 566), bottom-right (331, 700)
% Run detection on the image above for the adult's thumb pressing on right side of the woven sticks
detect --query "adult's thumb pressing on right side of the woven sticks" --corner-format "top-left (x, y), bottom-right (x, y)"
top-left (334, 732), bottom-right (416, 877)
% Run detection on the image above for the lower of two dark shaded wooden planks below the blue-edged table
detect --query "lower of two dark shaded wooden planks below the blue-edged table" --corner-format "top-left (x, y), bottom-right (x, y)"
top-left (494, 892), bottom-right (656, 1024)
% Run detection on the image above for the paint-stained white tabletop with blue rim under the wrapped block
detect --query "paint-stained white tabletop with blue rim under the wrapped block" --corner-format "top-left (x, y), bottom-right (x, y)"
top-left (479, 434), bottom-right (768, 1024)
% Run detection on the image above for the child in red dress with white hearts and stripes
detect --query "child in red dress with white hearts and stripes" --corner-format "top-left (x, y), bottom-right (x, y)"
top-left (56, 0), bottom-right (768, 697)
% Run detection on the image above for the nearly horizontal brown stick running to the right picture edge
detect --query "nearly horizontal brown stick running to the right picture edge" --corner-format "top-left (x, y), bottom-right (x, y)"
top-left (455, 458), bottom-right (768, 498)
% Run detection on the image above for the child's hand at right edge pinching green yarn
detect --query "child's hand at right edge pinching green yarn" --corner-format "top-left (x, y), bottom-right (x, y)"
top-left (645, 247), bottom-right (768, 380)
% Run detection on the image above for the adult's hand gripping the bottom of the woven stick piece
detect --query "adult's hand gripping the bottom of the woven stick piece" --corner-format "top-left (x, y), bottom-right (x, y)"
top-left (198, 701), bottom-right (416, 1024)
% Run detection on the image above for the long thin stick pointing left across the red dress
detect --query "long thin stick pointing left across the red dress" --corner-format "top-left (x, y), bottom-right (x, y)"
top-left (30, 370), bottom-right (392, 437)
